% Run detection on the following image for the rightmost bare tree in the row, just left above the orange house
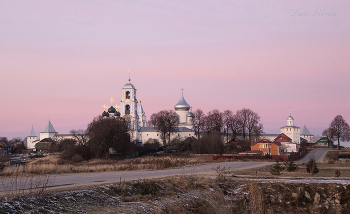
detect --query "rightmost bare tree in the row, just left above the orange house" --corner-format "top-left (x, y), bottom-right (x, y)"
top-left (236, 108), bottom-right (263, 141)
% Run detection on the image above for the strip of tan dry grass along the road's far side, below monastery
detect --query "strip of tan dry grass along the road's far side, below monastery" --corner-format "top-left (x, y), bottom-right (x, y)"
top-left (1, 155), bottom-right (220, 176)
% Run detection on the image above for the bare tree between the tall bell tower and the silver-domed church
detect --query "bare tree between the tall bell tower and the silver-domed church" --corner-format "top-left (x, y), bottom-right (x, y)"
top-left (148, 110), bottom-right (179, 145)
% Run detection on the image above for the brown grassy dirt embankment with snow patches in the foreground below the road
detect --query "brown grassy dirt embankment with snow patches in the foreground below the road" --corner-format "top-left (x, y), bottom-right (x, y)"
top-left (0, 174), bottom-right (350, 214)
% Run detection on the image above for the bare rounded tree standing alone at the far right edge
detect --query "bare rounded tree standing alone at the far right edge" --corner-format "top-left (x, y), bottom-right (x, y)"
top-left (322, 115), bottom-right (350, 149)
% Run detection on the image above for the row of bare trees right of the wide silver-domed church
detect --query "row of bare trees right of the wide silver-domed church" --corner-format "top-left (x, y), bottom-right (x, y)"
top-left (193, 108), bottom-right (263, 141)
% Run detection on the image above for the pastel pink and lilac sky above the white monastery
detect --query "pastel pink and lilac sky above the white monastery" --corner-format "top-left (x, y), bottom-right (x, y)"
top-left (0, 0), bottom-right (350, 138)
